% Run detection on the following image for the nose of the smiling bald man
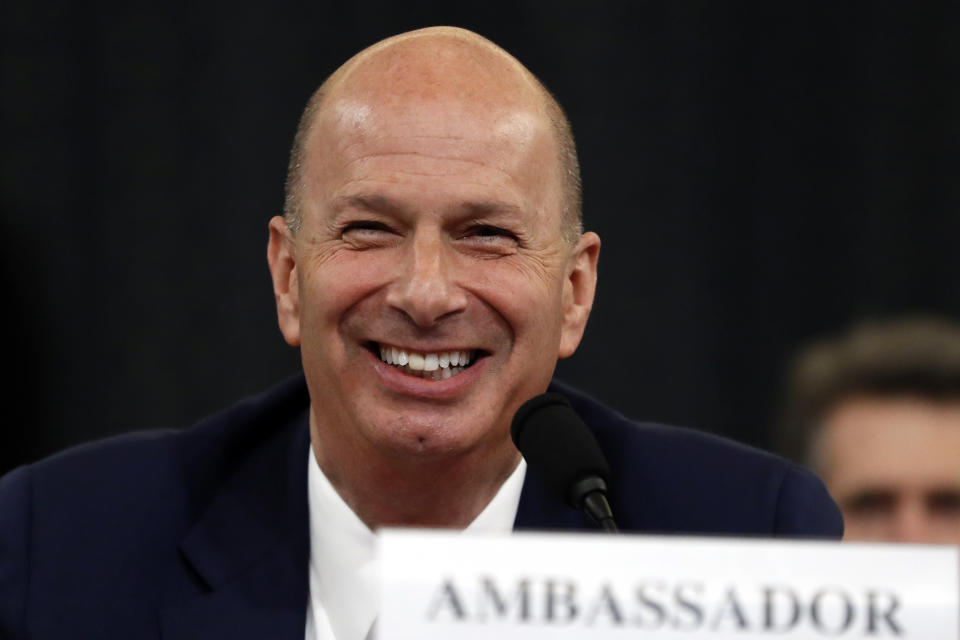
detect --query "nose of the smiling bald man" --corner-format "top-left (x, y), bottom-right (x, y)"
top-left (387, 235), bottom-right (467, 327)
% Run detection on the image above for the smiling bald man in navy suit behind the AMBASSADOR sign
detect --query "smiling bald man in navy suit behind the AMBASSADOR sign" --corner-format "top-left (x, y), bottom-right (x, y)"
top-left (0, 28), bottom-right (842, 640)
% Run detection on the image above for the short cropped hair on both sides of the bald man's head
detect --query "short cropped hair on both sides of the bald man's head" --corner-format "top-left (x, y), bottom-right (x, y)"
top-left (283, 77), bottom-right (583, 244)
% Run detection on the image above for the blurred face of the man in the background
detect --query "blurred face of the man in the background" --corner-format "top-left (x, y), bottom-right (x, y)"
top-left (819, 397), bottom-right (960, 544)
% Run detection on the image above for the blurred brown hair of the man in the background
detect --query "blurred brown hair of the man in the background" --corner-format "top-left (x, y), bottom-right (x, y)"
top-left (779, 316), bottom-right (960, 466)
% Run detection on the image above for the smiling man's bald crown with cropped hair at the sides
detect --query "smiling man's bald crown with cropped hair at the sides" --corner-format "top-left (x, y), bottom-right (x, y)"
top-left (284, 27), bottom-right (582, 243)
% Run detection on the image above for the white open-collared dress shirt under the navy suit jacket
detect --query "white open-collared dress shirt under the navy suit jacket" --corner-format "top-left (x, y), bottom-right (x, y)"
top-left (306, 449), bottom-right (527, 640)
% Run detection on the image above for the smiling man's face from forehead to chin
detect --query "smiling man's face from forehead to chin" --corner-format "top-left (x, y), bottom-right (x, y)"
top-left (272, 85), bottom-right (599, 458)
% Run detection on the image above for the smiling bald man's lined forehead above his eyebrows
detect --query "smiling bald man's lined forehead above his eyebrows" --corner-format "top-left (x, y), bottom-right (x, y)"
top-left (306, 100), bottom-right (560, 221)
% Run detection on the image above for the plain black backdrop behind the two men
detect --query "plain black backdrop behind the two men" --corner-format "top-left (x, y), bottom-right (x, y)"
top-left (0, 0), bottom-right (960, 471)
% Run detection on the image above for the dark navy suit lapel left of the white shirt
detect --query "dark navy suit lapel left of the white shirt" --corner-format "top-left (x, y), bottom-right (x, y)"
top-left (160, 412), bottom-right (309, 640)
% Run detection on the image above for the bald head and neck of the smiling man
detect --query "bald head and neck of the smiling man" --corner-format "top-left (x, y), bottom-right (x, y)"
top-left (269, 29), bottom-right (600, 527)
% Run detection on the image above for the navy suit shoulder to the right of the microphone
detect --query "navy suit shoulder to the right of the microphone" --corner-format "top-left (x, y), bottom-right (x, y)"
top-left (552, 381), bottom-right (843, 538)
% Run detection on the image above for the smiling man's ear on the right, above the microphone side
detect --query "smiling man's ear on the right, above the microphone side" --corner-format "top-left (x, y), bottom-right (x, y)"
top-left (557, 231), bottom-right (600, 358)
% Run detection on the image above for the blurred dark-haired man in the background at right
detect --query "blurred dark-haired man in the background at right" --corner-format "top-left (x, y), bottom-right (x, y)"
top-left (781, 317), bottom-right (960, 544)
